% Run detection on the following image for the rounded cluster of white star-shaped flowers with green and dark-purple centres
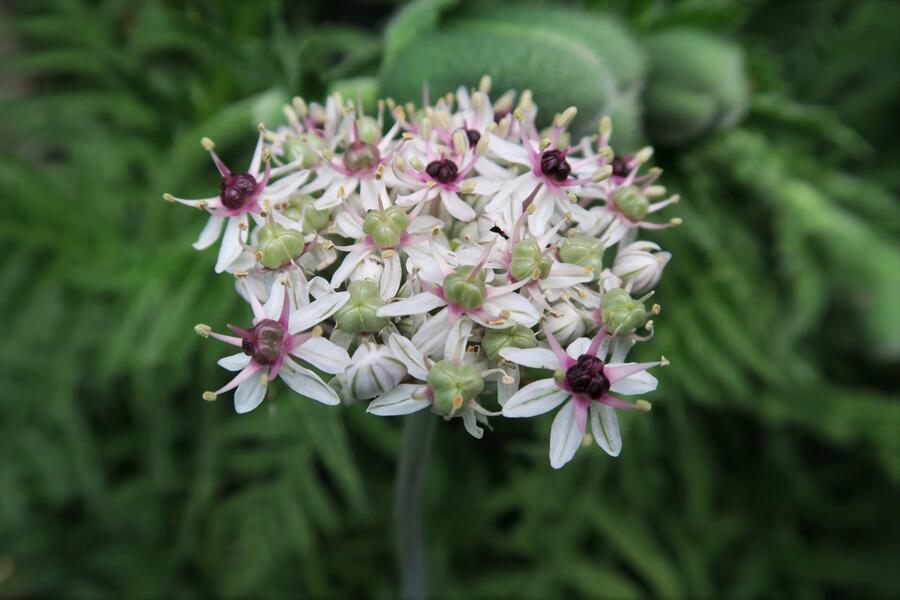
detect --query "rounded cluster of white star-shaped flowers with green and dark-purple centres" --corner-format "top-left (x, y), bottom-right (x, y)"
top-left (164, 77), bottom-right (679, 468)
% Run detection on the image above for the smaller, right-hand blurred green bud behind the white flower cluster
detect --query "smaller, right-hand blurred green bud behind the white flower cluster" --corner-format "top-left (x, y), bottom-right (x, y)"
top-left (644, 29), bottom-right (750, 144)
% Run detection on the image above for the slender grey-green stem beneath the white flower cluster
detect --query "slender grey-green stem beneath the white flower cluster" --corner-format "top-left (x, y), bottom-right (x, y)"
top-left (394, 410), bottom-right (436, 600)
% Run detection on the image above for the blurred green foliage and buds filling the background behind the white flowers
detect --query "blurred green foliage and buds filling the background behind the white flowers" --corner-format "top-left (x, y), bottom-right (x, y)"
top-left (0, 0), bottom-right (900, 598)
